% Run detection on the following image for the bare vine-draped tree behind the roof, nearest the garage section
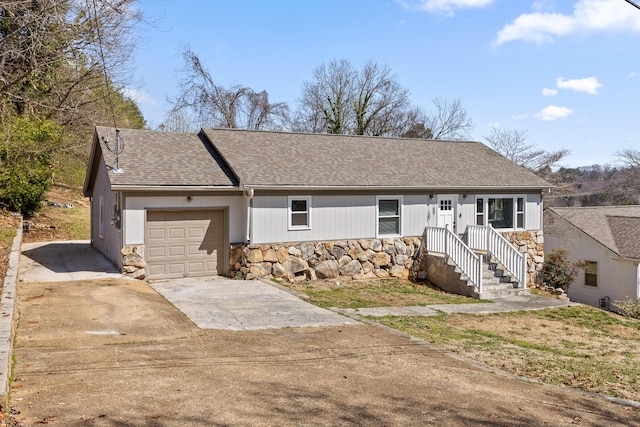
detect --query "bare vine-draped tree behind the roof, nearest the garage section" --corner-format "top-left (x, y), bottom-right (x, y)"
top-left (172, 48), bottom-right (289, 129)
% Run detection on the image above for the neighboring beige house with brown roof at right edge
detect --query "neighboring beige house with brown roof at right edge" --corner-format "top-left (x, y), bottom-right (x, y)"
top-left (544, 206), bottom-right (640, 310)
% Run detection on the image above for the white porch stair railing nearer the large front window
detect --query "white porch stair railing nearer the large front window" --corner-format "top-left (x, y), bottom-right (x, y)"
top-left (466, 225), bottom-right (527, 288)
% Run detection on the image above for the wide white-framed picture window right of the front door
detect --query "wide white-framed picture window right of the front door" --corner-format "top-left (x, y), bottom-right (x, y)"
top-left (476, 195), bottom-right (526, 230)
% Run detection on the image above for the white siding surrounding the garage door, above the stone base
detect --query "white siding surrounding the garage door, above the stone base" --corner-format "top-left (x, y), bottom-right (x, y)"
top-left (123, 195), bottom-right (245, 245)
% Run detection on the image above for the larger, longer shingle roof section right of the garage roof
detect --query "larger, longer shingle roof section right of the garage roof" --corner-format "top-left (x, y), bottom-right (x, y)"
top-left (202, 129), bottom-right (551, 188)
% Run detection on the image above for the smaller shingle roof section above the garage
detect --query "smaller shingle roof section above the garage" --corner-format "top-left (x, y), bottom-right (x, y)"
top-left (89, 127), bottom-right (238, 186)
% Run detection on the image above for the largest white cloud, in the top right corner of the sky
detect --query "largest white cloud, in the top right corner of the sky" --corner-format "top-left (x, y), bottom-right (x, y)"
top-left (494, 0), bottom-right (640, 46)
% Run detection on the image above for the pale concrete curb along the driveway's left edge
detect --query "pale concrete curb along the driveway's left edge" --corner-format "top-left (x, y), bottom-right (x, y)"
top-left (0, 217), bottom-right (23, 410)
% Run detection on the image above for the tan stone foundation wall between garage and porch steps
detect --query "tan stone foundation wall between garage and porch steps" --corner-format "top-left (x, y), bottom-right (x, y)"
top-left (229, 237), bottom-right (422, 281)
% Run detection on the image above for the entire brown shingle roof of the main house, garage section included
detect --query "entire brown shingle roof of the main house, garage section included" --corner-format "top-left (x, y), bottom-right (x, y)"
top-left (85, 127), bottom-right (551, 194)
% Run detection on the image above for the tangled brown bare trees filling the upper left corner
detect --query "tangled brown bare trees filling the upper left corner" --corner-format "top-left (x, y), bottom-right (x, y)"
top-left (0, 0), bottom-right (142, 126)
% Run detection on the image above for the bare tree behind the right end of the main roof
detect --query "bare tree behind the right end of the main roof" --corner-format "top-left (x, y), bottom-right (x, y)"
top-left (484, 128), bottom-right (570, 174)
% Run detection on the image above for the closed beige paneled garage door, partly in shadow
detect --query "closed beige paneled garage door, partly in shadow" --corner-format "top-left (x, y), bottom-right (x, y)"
top-left (146, 210), bottom-right (225, 279)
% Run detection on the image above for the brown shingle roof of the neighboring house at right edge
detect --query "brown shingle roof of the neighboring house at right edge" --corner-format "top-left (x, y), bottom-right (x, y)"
top-left (547, 205), bottom-right (640, 259)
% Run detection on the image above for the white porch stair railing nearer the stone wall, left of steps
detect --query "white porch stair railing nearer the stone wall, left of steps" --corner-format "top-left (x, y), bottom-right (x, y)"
top-left (423, 227), bottom-right (482, 293)
